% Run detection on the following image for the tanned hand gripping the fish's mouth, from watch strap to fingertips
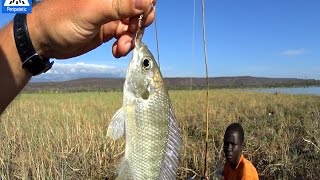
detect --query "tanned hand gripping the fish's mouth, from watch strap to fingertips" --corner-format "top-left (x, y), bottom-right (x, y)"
top-left (27, 0), bottom-right (156, 59)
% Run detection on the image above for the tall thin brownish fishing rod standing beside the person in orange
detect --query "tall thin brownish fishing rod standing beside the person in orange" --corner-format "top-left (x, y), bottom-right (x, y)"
top-left (202, 0), bottom-right (209, 177)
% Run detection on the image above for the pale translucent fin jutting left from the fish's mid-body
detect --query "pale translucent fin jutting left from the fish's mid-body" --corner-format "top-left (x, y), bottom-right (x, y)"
top-left (107, 108), bottom-right (125, 140)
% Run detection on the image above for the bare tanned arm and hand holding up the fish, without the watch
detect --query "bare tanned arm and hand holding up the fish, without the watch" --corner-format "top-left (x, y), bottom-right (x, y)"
top-left (0, 0), bottom-right (155, 114)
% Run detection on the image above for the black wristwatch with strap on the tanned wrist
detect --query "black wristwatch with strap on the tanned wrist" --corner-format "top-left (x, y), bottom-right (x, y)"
top-left (13, 14), bottom-right (54, 76)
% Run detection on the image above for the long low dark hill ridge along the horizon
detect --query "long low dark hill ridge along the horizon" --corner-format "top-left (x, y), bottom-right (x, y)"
top-left (24, 76), bottom-right (320, 92)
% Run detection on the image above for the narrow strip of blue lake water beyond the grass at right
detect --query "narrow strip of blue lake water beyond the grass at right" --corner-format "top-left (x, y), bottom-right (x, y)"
top-left (253, 86), bottom-right (320, 96)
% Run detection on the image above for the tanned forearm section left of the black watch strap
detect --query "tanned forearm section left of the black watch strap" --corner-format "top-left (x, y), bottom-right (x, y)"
top-left (0, 23), bottom-right (31, 114)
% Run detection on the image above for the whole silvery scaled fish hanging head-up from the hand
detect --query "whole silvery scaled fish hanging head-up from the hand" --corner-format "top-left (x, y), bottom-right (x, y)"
top-left (107, 31), bottom-right (182, 180)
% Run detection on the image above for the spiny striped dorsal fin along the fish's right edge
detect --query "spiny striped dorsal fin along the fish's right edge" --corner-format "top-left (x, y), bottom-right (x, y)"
top-left (159, 105), bottom-right (182, 179)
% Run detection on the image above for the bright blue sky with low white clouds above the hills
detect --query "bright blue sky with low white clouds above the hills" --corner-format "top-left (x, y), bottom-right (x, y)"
top-left (0, 0), bottom-right (320, 81)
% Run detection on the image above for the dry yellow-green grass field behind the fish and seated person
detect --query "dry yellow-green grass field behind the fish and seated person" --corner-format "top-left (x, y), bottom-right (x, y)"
top-left (0, 89), bottom-right (320, 179)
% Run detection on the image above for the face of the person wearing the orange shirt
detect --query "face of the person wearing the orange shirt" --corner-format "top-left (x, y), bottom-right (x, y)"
top-left (223, 131), bottom-right (242, 169)
